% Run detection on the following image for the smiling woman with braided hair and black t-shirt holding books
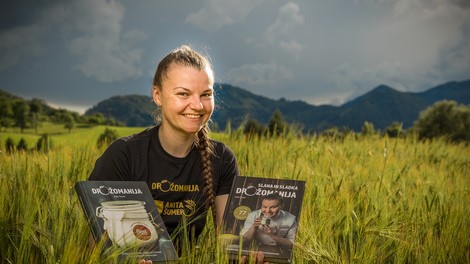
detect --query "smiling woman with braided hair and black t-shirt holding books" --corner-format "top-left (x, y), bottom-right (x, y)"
top-left (89, 45), bottom-right (239, 242)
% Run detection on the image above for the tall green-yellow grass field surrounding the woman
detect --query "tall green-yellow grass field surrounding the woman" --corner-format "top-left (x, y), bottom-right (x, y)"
top-left (0, 125), bottom-right (470, 264)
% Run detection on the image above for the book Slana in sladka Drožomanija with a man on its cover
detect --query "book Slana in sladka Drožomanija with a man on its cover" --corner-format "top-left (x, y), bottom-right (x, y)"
top-left (219, 176), bottom-right (305, 263)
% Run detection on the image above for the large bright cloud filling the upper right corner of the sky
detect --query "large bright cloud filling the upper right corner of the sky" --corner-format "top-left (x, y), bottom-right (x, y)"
top-left (338, 0), bottom-right (470, 97)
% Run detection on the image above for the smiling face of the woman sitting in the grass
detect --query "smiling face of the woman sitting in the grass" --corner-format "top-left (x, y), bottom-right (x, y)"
top-left (153, 64), bottom-right (214, 134)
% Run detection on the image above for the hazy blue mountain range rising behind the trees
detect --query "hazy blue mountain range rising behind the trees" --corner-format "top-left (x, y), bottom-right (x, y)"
top-left (86, 80), bottom-right (470, 132)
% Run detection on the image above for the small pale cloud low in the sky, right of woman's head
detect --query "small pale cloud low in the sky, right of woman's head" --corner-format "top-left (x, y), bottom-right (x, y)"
top-left (227, 63), bottom-right (293, 86)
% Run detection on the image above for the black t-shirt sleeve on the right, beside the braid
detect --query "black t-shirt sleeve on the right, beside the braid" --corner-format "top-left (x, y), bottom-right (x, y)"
top-left (216, 145), bottom-right (239, 195)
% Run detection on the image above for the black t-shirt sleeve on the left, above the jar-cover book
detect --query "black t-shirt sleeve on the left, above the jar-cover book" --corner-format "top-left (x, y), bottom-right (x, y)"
top-left (88, 139), bottom-right (131, 181)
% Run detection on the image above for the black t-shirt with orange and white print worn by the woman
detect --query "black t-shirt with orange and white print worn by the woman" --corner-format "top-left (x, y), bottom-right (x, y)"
top-left (89, 126), bottom-right (239, 235)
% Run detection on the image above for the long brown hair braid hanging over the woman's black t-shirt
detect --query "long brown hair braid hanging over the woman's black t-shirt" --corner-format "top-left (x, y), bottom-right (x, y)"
top-left (196, 125), bottom-right (216, 224)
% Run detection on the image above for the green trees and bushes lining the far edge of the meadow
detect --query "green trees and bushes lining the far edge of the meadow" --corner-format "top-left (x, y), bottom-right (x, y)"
top-left (0, 96), bottom-right (470, 154)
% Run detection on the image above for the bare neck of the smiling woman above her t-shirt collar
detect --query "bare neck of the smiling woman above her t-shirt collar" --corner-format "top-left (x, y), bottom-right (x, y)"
top-left (158, 124), bottom-right (195, 158)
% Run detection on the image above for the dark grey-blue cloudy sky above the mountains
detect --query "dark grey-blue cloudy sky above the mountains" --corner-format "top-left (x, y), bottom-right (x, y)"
top-left (0, 0), bottom-right (470, 113)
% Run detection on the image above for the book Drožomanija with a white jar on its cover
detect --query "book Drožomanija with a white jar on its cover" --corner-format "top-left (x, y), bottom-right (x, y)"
top-left (75, 181), bottom-right (178, 263)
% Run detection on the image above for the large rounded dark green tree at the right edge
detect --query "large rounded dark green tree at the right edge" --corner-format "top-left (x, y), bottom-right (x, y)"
top-left (413, 100), bottom-right (470, 141)
